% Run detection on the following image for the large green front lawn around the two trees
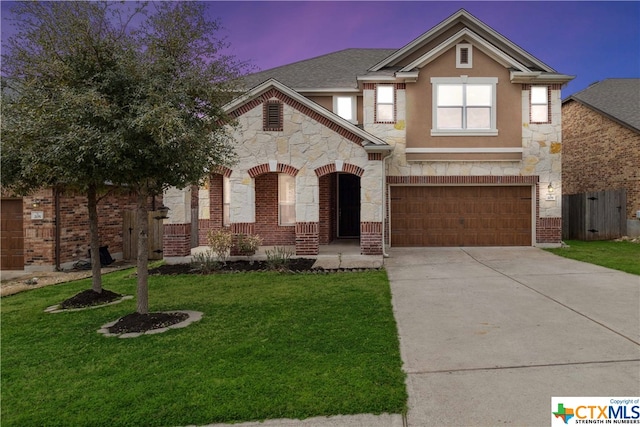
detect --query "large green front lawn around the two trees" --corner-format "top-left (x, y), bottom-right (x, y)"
top-left (0, 270), bottom-right (407, 427)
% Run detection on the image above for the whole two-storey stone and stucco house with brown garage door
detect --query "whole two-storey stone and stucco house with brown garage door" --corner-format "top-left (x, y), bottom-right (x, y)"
top-left (164, 10), bottom-right (573, 257)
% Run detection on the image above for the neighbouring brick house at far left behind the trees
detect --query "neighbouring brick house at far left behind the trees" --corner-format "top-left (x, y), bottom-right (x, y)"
top-left (0, 188), bottom-right (162, 271)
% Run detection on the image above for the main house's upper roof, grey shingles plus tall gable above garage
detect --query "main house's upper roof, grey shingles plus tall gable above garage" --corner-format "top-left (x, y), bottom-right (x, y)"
top-left (242, 9), bottom-right (574, 93)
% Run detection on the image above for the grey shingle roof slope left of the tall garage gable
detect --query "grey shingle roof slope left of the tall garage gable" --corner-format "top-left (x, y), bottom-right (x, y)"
top-left (243, 49), bottom-right (396, 91)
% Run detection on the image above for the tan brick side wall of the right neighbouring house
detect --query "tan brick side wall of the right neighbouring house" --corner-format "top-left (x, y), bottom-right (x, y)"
top-left (562, 101), bottom-right (640, 219)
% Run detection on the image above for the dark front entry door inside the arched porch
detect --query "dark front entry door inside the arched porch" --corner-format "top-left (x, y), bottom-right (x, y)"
top-left (338, 174), bottom-right (360, 241)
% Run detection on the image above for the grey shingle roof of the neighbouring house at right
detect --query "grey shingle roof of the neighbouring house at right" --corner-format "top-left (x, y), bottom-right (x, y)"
top-left (563, 79), bottom-right (640, 131)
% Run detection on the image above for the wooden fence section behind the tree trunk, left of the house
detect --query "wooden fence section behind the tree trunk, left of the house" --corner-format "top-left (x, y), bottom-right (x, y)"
top-left (122, 210), bottom-right (164, 259)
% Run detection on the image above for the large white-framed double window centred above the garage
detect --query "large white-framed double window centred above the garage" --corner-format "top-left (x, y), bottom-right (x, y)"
top-left (431, 76), bottom-right (498, 135)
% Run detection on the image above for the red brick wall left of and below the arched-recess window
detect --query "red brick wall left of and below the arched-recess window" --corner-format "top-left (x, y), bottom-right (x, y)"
top-left (255, 173), bottom-right (296, 246)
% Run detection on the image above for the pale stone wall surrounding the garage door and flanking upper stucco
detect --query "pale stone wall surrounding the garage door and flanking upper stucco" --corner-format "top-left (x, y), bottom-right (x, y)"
top-left (364, 84), bottom-right (562, 243)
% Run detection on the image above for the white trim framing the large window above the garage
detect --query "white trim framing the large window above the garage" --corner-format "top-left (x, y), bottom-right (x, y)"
top-left (431, 76), bottom-right (498, 136)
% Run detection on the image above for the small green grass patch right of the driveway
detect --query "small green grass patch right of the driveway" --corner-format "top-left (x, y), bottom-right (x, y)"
top-left (547, 240), bottom-right (640, 275)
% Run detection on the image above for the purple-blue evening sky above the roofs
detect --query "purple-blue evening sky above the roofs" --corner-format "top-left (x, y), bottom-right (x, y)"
top-left (2, 1), bottom-right (640, 97)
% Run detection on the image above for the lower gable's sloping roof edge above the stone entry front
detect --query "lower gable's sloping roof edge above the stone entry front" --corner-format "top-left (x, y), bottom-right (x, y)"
top-left (222, 79), bottom-right (393, 152)
